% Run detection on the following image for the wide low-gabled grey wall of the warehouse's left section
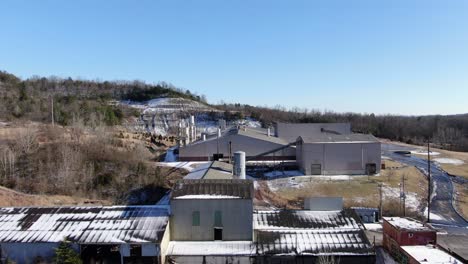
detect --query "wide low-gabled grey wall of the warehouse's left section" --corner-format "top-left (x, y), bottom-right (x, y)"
top-left (179, 134), bottom-right (296, 161)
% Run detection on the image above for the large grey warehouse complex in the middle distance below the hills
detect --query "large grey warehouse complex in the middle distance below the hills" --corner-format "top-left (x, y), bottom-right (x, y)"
top-left (179, 123), bottom-right (381, 175)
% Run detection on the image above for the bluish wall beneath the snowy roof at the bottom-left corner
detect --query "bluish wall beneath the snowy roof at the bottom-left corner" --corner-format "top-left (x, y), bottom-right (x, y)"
top-left (0, 243), bottom-right (72, 264)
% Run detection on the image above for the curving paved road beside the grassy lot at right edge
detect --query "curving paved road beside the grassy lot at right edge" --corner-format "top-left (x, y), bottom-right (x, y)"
top-left (382, 144), bottom-right (468, 234)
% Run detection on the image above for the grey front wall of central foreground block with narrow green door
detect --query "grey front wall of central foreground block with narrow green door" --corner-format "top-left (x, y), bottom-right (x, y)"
top-left (170, 199), bottom-right (253, 241)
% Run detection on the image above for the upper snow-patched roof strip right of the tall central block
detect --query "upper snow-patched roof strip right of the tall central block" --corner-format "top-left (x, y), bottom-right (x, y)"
top-left (254, 210), bottom-right (361, 230)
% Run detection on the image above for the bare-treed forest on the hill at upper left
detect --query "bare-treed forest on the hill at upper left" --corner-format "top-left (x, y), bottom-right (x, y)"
top-left (0, 71), bottom-right (206, 127)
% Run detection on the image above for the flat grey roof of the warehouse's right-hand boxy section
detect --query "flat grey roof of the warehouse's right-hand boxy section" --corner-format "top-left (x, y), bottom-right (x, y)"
top-left (300, 133), bottom-right (379, 143)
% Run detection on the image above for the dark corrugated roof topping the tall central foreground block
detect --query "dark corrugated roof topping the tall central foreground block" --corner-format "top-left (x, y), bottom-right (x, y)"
top-left (171, 179), bottom-right (254, 199)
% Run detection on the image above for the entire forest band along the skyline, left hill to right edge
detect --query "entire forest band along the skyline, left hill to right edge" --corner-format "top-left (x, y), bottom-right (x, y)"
top-left (0, 71), bottom-right (468, 151)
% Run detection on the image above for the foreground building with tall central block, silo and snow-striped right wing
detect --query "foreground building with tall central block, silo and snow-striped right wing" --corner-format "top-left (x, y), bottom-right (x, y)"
top-left (164, 157), bottom-right (375, 264)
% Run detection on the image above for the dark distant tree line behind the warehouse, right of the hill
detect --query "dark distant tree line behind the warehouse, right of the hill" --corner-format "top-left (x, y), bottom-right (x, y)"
top-left (218, 104), bottom-right (468, 151)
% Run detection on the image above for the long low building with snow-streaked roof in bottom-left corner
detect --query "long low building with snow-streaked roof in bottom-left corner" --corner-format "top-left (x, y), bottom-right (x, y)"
top-left (0, 206), bottom-right (169, 264)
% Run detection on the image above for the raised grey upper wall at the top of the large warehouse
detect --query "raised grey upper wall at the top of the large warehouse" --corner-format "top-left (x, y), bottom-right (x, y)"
top-left (275, 123), bottom-right (351, 142)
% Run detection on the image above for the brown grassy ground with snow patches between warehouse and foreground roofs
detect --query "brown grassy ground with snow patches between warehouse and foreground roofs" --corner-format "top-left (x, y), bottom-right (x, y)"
top-left (262, 160), bottom-right (427, 216)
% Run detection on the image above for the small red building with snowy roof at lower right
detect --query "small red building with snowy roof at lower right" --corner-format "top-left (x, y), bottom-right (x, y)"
top-left (383, 217), bottom-right (437, 259)
